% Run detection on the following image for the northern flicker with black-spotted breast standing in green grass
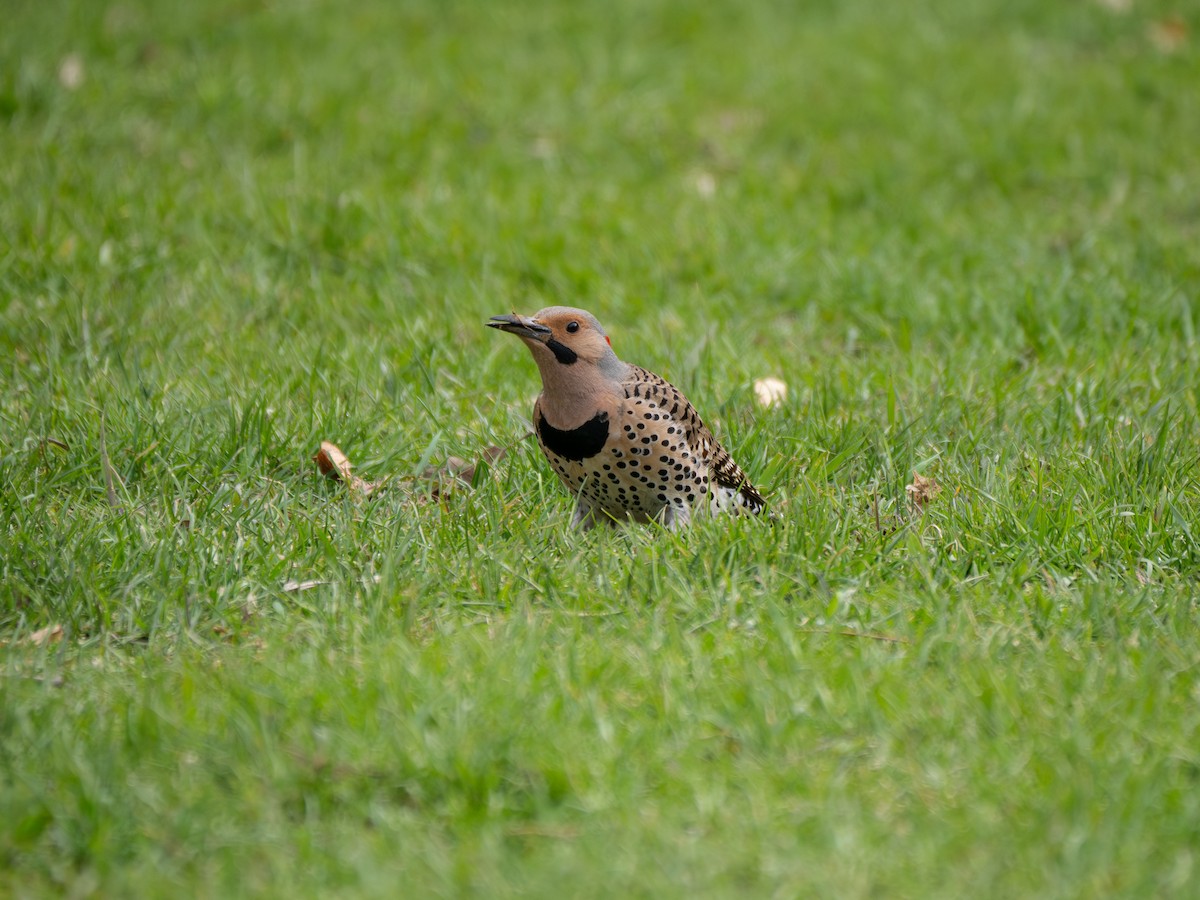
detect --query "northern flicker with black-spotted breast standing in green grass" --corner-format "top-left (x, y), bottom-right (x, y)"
top-left (487, 306), bottom-right (766, 529)
